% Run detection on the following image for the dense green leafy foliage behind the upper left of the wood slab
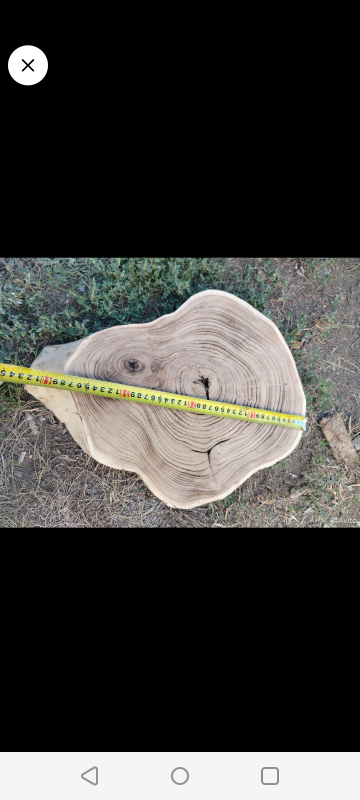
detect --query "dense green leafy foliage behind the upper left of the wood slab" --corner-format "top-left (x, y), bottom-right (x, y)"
top-left (0, 258), bottom-right (274, 366)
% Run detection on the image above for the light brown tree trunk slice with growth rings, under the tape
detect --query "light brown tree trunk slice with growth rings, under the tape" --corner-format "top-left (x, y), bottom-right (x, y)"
top-left (26, 290), bottom-right (306, 509)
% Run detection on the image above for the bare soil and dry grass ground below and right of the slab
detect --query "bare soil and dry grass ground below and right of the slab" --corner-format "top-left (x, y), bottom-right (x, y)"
top-left (0, 258), bottom-right (360, 529)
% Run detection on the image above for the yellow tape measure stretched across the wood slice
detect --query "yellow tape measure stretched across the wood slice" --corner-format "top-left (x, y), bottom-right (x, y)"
top-left (0, 364), bottom-right (306, 431)
